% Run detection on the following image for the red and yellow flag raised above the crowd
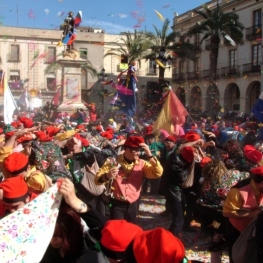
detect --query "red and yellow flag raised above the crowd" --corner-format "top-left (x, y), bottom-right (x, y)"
top-left (153, 90), bottom-right (188, 135)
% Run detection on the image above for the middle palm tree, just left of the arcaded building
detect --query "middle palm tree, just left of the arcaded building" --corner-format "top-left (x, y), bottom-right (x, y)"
top-left (144, 19), bottom-right (196, 83)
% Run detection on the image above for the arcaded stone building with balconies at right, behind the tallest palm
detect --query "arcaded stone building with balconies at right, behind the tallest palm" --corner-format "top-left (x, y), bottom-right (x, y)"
top-left (172, 0), bottom-right (263, 116)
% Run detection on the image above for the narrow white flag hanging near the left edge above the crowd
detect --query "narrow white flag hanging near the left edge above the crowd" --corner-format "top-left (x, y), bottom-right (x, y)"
top-left (3, 73), bottom-right (17, 124)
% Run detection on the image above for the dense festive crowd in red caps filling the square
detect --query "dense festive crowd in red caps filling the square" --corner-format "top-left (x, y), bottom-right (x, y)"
top-left (0, 100), bottom-right (263, 263)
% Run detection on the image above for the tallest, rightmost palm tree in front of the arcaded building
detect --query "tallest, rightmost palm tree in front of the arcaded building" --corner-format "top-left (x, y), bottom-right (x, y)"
top-left (188, 3), bottom-right (244, 83)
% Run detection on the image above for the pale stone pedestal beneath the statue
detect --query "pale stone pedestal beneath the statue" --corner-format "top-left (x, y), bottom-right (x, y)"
top-left (58, 58), bottom-right (86, 112)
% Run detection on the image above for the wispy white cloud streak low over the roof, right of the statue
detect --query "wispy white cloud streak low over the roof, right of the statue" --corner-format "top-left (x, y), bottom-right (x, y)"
top-left (81, 20), bottom-right (134, 34)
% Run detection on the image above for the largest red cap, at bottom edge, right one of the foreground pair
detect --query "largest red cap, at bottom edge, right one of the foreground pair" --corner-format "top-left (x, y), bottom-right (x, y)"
top-left (132, 228), bottom-right (185, 263)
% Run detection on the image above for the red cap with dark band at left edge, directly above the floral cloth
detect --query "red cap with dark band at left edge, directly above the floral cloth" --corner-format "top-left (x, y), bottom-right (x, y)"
top-left (0, 175), bottom-right (28, 203)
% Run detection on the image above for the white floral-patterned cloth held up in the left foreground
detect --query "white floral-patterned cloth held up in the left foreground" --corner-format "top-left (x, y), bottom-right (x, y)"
top-left (0, 184), bottom-right (62, 263)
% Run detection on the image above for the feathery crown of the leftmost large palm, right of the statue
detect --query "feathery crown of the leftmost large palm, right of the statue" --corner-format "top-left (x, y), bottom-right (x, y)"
top-left (104, 30), bottom-right (151, 65)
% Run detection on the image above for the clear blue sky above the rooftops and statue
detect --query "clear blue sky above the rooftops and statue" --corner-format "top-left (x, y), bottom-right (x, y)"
top-left (0, 0), bottom-right (204, 34)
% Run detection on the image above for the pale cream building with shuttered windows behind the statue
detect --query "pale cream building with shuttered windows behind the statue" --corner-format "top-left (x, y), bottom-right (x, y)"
top-left (0, 26), bottom-right (172, 113)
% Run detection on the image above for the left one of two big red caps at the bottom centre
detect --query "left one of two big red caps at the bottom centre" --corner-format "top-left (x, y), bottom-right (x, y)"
top-left (100, 220), bottom-right (143, 262)
